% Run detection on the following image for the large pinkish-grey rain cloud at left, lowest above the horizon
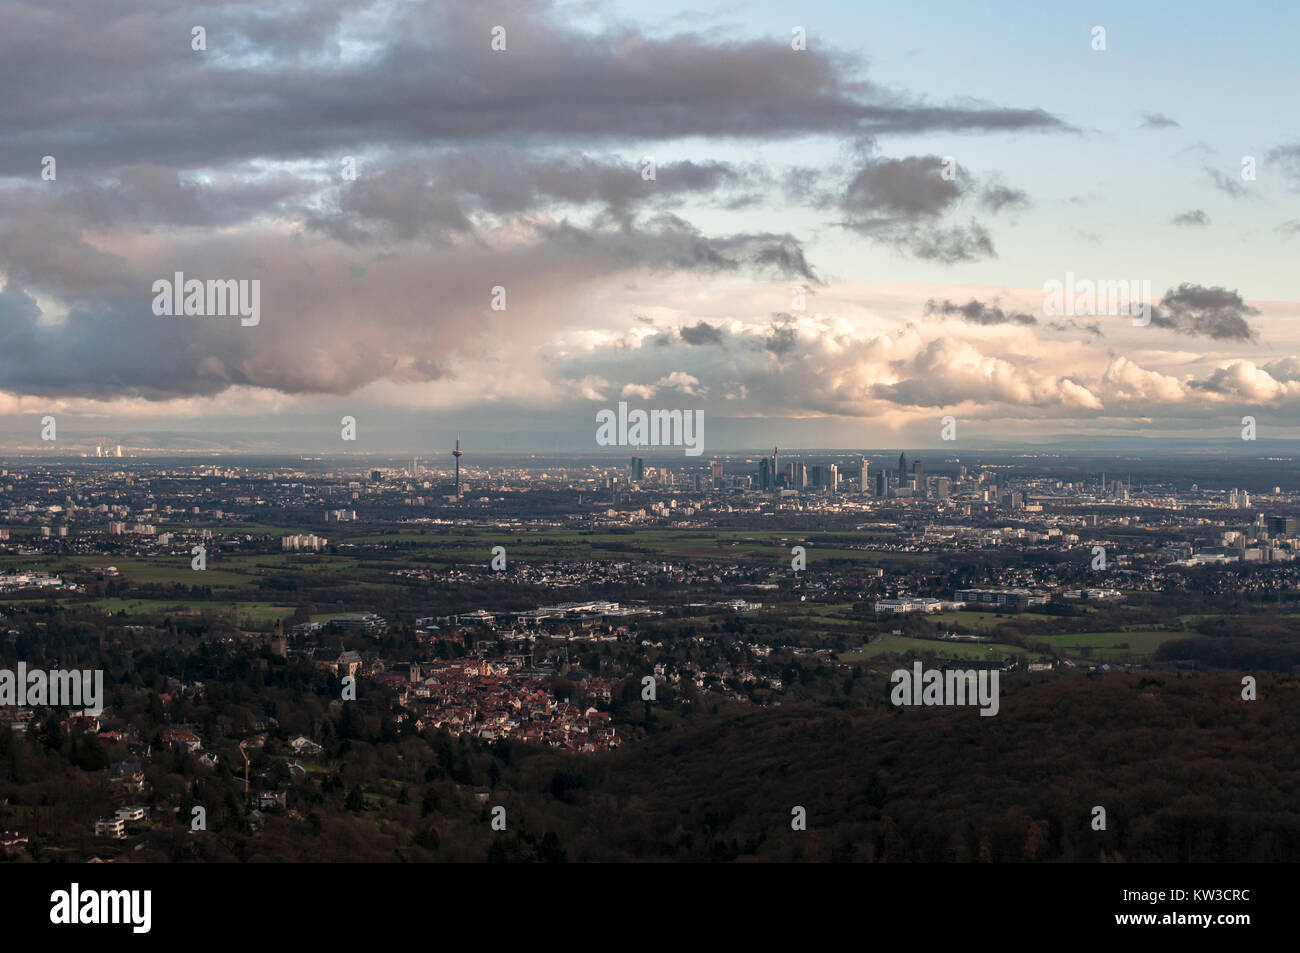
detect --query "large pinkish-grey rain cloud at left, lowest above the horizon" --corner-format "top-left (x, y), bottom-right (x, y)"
top-left (0, 235), bottom-right (621, 400)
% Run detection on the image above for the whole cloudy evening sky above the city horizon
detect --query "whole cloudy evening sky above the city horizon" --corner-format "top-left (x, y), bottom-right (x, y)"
top-left (0, 0), bottom-right (1300, 452)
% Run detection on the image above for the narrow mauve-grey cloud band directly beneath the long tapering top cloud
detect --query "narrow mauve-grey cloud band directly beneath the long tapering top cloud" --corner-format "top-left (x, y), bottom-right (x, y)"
top-left (27, 151), bottom-right (763, 243)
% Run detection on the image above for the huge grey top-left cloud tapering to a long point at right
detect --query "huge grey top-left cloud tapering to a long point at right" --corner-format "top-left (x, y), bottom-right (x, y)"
top-left (0, 0), bottom-right (1067, 174)
